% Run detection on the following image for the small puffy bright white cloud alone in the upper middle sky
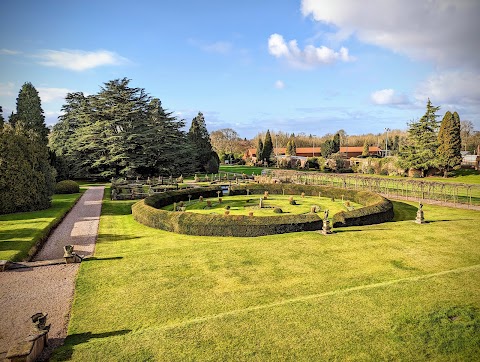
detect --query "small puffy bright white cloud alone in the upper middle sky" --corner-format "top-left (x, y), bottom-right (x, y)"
top-left (268, 34), bottom-right (355, 69)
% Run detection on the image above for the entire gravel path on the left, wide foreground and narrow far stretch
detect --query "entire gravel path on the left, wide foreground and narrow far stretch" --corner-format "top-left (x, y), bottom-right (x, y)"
top-left (0, 186), bottom-right (104, 361)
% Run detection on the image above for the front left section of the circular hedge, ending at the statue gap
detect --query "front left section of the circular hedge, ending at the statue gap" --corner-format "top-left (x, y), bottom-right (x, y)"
top-left (132, 198), bottom-right (323, 237)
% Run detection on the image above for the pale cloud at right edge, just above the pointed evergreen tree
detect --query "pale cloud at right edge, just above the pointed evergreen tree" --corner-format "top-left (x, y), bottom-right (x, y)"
top-left (415, 71), bottom-right (480, 105)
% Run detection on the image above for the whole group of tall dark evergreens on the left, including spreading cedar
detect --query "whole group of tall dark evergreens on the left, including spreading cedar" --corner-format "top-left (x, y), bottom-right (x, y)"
top-left (0, 78), bottom-right (220, 213)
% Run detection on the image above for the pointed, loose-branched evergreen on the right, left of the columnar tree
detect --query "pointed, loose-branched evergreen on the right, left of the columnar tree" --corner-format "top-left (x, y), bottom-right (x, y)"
top-left (399, 99), bottom-right (440, 176)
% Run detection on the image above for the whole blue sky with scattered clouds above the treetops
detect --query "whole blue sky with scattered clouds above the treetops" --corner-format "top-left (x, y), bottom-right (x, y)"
top-left (0, 0), bottom-right (480, 138)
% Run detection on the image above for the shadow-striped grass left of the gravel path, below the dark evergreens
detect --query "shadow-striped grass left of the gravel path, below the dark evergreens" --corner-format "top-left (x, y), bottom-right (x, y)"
top-left (0, 193), bottom-right (81, 261)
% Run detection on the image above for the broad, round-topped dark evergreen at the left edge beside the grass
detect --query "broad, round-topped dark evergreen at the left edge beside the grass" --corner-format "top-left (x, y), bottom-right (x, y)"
top-left (0, 123), bottom-right (55, 214)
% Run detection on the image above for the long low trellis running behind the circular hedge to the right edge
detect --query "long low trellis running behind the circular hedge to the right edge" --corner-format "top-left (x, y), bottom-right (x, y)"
top-left (268, 170), bottom-right (480, 206)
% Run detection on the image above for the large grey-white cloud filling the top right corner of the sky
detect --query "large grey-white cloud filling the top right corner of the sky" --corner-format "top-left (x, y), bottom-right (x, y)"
top-left (302, 0), bottom-right (480, 67)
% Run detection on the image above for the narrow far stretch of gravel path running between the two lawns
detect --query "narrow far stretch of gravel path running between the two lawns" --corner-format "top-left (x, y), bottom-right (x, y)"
top-left (34, 186), bottom-right (104, 260)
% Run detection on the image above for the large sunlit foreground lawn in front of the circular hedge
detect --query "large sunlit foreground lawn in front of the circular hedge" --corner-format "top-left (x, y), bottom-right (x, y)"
top-left (53, 194), bottom-right (480, 361)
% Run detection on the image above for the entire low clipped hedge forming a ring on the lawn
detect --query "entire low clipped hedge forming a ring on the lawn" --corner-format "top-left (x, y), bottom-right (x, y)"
top-left (132, 184), bottom-right (393, 237)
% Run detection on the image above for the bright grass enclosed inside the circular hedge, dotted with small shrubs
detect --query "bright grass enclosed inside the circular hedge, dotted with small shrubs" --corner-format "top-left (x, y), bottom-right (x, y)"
top-left (163, 195), bottom-right (362, 216)
